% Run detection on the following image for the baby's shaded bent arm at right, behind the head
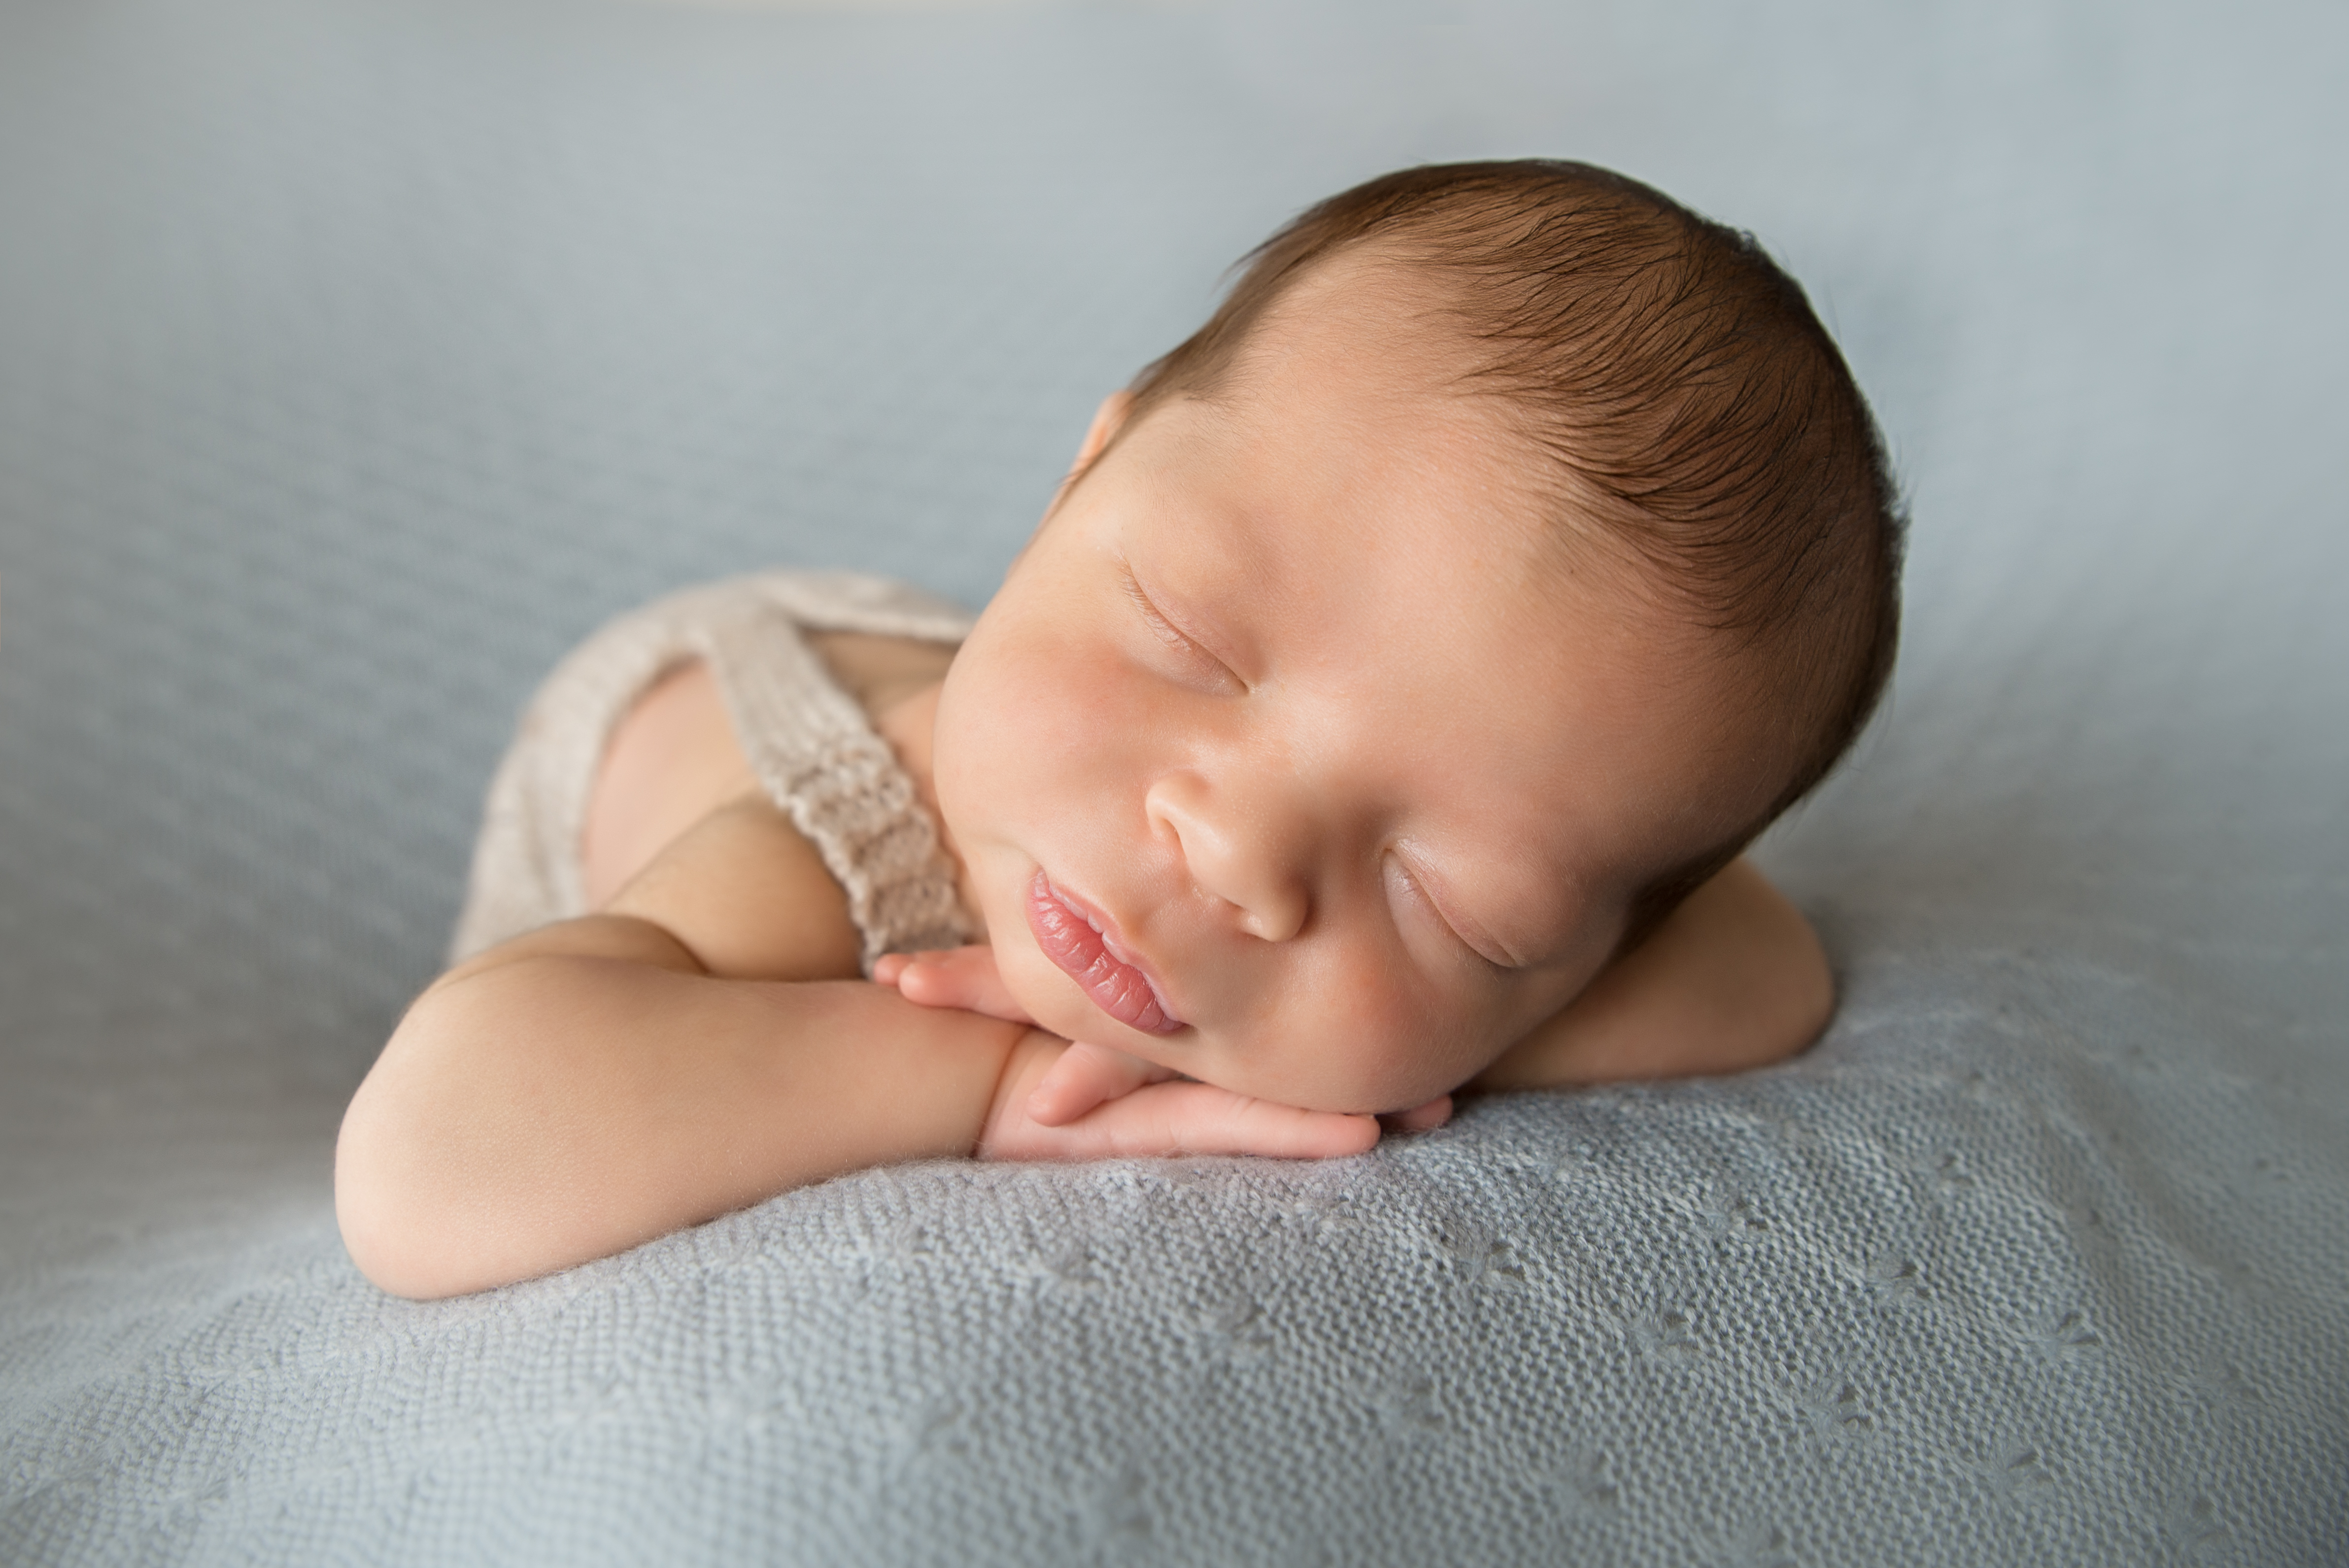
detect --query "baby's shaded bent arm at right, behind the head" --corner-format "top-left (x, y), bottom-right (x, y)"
top-left (1468, 859), bottom-right (1835, 1089)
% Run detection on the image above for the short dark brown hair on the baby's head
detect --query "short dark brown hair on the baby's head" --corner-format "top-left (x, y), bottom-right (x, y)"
top-left (1125, 160), bottom-right (1905, 941)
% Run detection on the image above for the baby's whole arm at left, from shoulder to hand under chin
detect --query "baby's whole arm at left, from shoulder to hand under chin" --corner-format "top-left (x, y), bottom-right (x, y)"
top-left (336, 798), bottom-right (1379, 1295)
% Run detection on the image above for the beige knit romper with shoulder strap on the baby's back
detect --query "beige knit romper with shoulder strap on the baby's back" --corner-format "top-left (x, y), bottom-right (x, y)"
top-left (448, 573), bottom-right (975, 974)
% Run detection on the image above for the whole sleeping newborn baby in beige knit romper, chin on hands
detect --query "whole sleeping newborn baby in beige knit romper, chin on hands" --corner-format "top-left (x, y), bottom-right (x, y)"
top-left (336, 162), bottom-right (1901, 1295)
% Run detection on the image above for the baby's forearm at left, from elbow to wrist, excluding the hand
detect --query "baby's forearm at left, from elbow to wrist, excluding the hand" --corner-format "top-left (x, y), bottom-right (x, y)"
top-left (336, 916), bottom-right (1026, 1295)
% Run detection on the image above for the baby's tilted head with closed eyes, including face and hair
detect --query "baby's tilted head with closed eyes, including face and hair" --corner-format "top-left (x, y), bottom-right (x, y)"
top-left (935, 162), bottom-right (1901, 1110)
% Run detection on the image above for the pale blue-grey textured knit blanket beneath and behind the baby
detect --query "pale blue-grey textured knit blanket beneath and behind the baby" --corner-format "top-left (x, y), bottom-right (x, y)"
top-left (0, 0), bottom-right (2349, 1568)
